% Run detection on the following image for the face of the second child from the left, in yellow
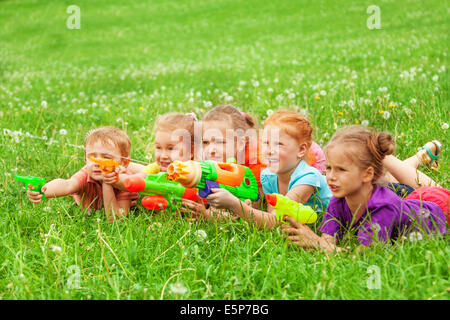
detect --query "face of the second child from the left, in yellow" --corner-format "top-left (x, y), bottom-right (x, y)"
top-left (155, 130), bottom-right (192, 171)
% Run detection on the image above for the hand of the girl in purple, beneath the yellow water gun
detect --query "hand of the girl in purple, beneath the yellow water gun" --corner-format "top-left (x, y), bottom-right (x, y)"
top-left (281, 216), bottom-right (319, 248)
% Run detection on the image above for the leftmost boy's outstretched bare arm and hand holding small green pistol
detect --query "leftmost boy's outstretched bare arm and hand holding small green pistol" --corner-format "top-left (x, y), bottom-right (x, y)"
top-left (27, 178), bottom-right (80, 203)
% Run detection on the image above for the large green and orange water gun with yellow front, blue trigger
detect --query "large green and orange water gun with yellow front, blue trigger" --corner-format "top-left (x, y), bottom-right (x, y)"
top-left (167, 160), bottom-right (259, 201)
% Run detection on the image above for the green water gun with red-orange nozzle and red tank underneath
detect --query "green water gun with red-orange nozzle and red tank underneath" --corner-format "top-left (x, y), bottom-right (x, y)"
top-left (123, 172), bottom-right (197, 211)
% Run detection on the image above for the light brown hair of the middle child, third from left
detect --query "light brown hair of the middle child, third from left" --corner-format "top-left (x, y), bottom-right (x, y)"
top-left (202, 105), bottom-right (257, 131)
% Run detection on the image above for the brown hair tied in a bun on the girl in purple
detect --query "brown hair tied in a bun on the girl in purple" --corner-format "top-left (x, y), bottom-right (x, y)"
top-left (325, 126), bottom-right (395, 181)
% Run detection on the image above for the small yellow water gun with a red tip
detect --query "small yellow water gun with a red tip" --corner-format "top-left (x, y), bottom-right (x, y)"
top-left (266, 193), bottom-right (317, 223)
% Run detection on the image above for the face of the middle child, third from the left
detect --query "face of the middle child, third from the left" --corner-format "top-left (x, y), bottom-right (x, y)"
top-left (202, 121), bottom-right (245, 162)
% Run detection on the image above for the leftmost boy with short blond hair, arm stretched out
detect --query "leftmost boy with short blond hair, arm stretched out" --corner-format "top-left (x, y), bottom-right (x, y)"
top-left (27, 127), bottom-right (138, 221)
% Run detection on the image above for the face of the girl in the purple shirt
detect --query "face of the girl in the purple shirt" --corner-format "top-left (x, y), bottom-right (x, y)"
top-left (326, 145), bottom-right (373, 198)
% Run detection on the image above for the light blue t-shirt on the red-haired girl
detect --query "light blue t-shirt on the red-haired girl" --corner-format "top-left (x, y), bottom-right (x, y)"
top-left (261, 160), bottom-right (332, 212)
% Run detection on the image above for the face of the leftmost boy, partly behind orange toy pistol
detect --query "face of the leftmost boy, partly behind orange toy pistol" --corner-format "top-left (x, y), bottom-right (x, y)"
top-left (85, 141), bottom-right (128, 181)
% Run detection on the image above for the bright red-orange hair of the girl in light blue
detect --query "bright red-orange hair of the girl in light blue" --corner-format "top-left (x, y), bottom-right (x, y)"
top-left (264, 109), bottom-right (313, 149)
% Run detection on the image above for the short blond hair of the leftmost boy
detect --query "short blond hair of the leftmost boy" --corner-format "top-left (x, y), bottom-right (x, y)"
top-left (84, 126), bottom-right (131, 157)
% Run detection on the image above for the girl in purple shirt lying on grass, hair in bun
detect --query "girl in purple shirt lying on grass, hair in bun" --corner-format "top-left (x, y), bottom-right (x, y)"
top-left (282, 126), bottom-right (448, 252)
